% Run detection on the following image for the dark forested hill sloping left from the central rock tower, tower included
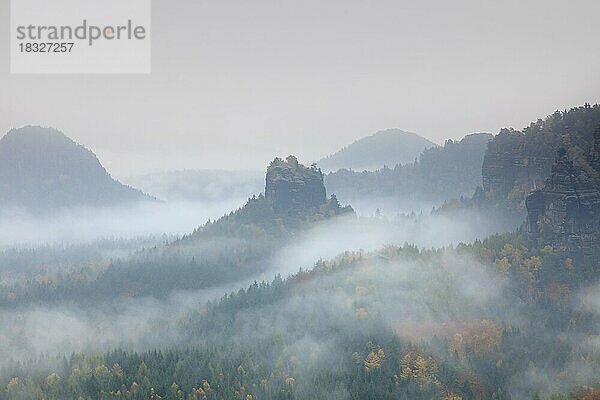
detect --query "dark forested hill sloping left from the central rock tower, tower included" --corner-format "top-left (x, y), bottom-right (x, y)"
top-left (0, 156), bottom-right (353, 306)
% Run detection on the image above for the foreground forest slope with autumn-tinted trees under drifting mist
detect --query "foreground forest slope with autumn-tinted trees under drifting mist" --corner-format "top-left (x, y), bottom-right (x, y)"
top-left (0, 234), bottom-right (600, 400)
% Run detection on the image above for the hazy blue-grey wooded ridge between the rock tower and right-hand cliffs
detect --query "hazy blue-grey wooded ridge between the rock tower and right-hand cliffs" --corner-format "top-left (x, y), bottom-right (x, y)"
top-left (325, 133), bottom-right (492, 202)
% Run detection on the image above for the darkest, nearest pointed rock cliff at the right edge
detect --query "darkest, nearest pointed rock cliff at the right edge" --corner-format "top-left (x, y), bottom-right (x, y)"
top-left (526, 149), bottom-right (600, 257)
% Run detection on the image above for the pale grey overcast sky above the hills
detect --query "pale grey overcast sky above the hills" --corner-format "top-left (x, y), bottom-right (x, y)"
top-left (0, 0), bottom-right (600, 177)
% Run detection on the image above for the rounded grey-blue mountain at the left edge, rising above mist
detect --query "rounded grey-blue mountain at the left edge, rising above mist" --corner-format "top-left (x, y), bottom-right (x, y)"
top-left (0, 126), bottom-right (155, 213)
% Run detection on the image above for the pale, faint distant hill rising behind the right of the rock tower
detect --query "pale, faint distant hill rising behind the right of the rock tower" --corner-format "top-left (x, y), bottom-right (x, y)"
top-left (317, 129), bottom-right (437, 171)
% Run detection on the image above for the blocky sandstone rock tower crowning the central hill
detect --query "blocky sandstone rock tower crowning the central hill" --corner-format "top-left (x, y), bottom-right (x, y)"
top-left (265, 156), bottom-right (327, 216)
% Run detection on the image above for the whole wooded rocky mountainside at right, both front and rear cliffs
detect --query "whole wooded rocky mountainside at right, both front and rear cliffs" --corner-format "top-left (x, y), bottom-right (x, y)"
top-left (440, 104), bottom-right (600, 239)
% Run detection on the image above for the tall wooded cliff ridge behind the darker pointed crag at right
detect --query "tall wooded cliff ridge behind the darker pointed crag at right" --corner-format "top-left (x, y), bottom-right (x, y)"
top-left (440, 104), bottom-right (600, 229)
